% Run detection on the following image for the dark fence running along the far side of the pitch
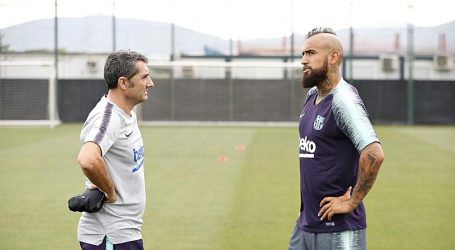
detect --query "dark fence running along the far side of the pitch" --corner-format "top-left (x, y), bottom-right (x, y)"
top-left (0, 64), bottom-right (455, 124)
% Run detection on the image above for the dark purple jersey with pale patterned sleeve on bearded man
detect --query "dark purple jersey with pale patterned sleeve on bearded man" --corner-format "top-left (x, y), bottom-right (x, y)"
top-left (297, 79), bottom-right (379, 233)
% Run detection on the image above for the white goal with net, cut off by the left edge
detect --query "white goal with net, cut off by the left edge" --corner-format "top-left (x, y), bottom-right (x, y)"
top-left (0, 61), bottom-right (60, 127)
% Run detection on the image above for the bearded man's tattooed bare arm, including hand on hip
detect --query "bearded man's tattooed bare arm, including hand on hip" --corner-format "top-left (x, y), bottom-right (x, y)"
top-left (318, 142), bottom-right (384, 220)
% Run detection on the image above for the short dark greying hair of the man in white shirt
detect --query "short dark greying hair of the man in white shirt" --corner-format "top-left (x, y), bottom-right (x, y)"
top-left (104, 50), bottom-right (148, 89)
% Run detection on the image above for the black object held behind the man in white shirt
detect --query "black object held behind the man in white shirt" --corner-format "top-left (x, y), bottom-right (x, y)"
top-left (68, 188), bottom-right (105, 213)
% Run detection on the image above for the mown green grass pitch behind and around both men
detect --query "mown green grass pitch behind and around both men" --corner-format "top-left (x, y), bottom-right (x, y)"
top-left (0, 124), bottom-right (455, 250)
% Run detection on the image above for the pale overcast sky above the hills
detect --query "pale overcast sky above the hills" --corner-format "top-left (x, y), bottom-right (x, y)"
top-left (0, 0), bottom-right (455, 39)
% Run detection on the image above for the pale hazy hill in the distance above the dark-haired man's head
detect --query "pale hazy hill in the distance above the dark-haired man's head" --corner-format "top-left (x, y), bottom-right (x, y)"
top-left (2, 16), bottom-right (229, 58)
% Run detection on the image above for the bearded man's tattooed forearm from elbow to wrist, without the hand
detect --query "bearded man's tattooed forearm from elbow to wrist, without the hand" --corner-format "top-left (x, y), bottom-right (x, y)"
top-left (351, 142), bottom-right (384, 203)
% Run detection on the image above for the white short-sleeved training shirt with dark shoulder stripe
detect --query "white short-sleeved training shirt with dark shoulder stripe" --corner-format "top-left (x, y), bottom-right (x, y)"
top-left (77, 96), bottom-right (146, 245)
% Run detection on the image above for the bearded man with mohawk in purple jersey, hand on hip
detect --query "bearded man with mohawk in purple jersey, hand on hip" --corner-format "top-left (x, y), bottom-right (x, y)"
top-left (288, 28), bottom-right (384, 250)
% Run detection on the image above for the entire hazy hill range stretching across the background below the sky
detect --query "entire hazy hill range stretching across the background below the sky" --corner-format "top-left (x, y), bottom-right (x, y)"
top-left (1, 16), bottom-right (455, 59)
